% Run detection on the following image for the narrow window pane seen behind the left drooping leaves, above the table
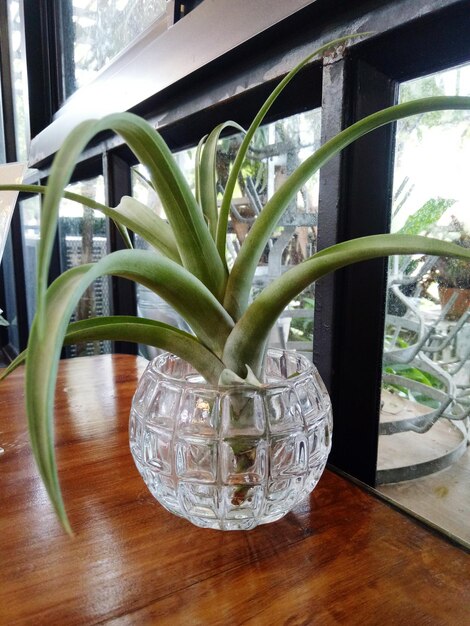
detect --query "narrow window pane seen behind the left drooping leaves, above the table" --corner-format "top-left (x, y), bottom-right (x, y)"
top-left (59, 176), bottom-right (111, 356)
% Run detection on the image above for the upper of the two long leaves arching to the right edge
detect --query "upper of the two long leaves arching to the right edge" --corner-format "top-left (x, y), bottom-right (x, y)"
top-left (224, 96), bottom-right (470, 320)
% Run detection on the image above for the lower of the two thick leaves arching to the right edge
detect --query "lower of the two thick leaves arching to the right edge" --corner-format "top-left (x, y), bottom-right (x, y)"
top-left (222, 234), bottom-right (470, 376)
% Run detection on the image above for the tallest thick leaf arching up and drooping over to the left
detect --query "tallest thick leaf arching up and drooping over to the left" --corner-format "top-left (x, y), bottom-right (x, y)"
top-left (32, 113), bottom-right (226, 335)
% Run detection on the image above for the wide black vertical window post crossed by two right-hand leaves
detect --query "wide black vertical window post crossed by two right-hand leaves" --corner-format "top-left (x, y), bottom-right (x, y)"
top-left (324, 60), bottom-right (396, 485)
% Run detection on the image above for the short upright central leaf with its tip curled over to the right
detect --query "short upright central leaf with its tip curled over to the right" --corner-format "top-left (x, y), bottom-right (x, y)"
top-left (199, 121), bottom-right (245, 244)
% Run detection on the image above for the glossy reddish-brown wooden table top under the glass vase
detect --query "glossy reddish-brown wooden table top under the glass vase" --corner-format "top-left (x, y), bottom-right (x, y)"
top-left (0, 355), bottom-right (470, 626)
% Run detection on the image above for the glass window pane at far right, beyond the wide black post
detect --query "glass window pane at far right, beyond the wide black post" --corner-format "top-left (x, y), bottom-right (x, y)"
top-left (377, 65), bottom-right (470, 542)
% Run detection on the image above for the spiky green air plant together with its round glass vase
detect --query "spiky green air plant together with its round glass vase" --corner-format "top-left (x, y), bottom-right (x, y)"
top-left (0, 38), bottom-right (470, 530)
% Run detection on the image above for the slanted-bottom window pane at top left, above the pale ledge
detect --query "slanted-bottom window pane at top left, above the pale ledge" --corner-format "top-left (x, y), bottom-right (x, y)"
top-left (60, 0), bottom-right (166, 97)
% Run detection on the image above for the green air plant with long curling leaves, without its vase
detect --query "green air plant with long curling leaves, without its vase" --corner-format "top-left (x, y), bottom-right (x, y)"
top-left (0, 37), bottom-right (470, 530)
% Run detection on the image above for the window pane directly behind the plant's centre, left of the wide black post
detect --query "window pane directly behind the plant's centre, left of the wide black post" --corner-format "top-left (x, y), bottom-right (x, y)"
top-left (133, 109), bottom-right (320, 358)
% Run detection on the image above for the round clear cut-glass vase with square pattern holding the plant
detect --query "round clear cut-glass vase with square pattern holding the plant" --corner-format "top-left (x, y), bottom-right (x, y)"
top-left (129, 350), bottom-right (332, 530)
